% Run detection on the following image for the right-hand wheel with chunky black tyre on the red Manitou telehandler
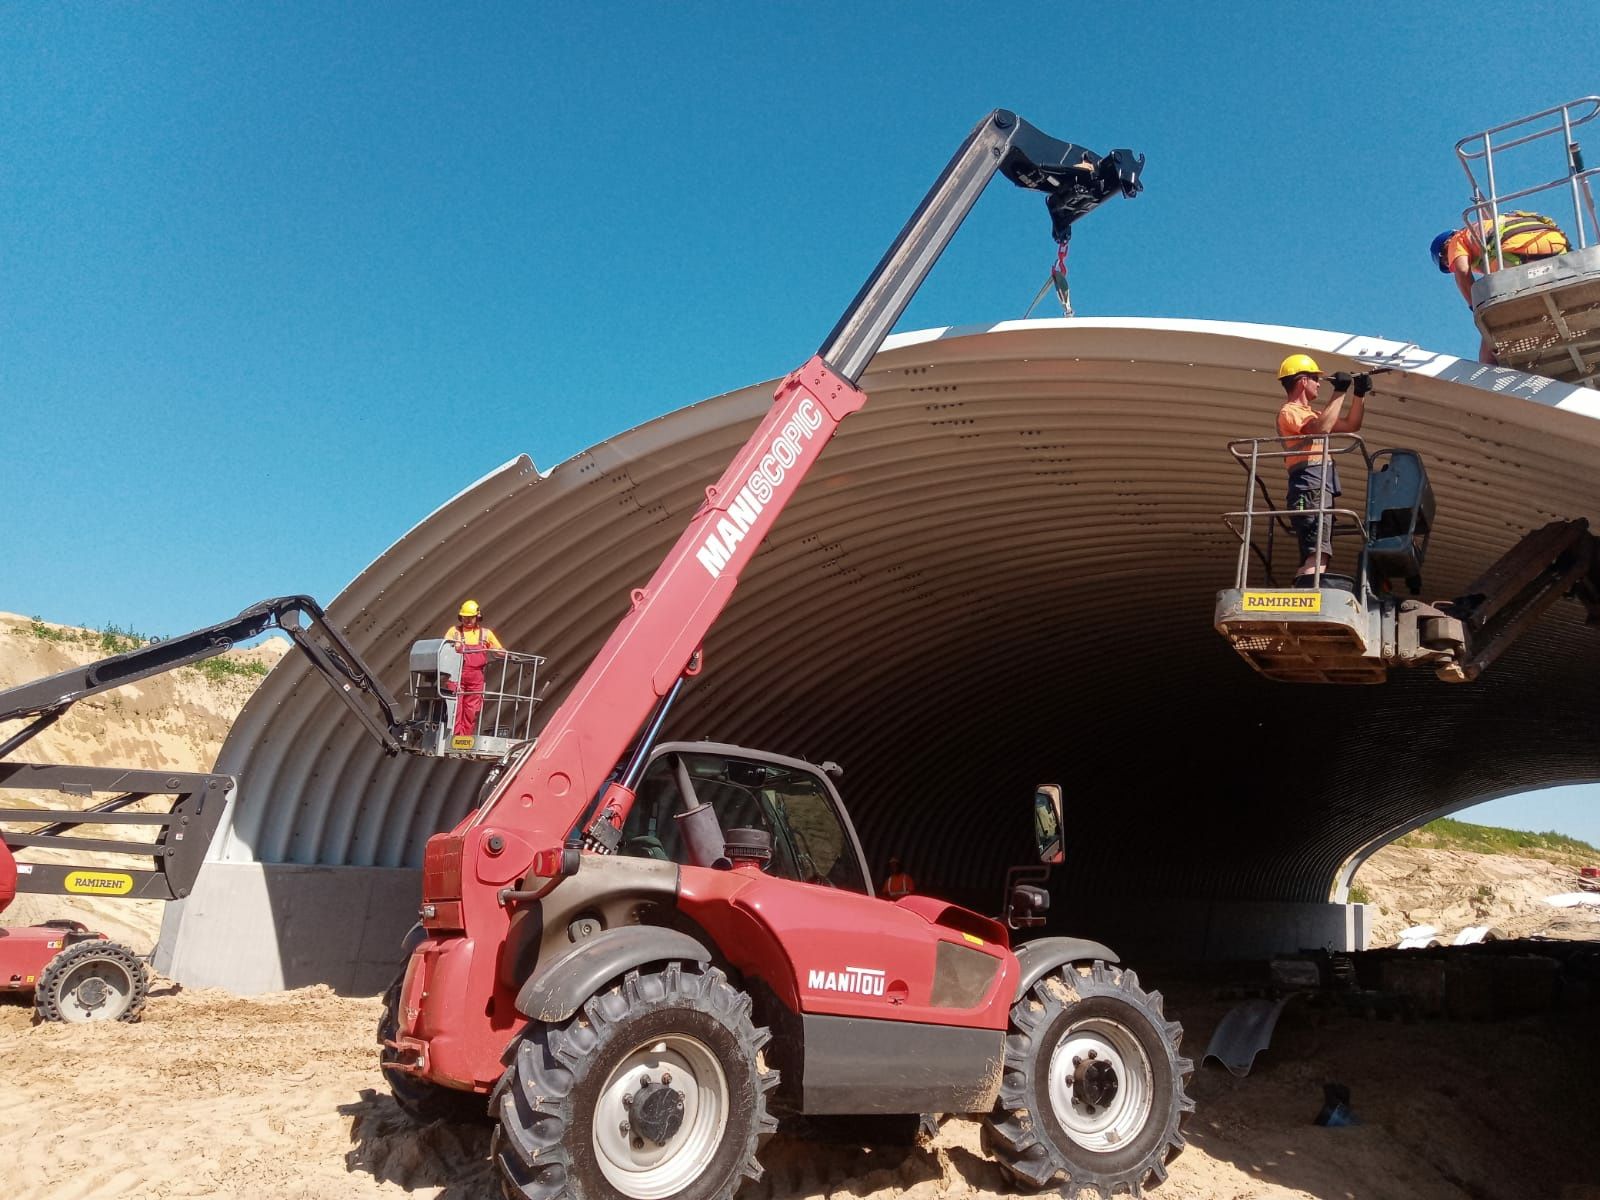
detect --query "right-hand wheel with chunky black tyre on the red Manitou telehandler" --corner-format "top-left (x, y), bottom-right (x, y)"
top-left (984, 962), bottom-right (1195, 1200)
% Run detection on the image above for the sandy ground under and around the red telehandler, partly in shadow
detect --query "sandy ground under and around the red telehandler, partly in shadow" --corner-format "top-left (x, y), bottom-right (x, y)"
top-left (0, 984), bottom-right (1600, 1200)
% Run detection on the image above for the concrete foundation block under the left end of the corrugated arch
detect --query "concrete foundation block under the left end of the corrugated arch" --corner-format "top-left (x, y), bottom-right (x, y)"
top-left (155, 862), bottom-right (422, 995)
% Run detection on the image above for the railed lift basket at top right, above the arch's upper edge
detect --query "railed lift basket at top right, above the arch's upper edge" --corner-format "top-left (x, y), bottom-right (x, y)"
top-left (1456, 96), bottom-right (1600, 387)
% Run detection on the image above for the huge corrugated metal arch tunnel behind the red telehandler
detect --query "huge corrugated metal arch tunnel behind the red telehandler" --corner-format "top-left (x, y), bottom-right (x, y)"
top-left (213, 320), bottom-right (1600, 906)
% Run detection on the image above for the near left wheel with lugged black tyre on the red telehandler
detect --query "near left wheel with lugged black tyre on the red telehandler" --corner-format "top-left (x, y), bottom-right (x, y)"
top-left (493, 963), bottom-right (778, 1200)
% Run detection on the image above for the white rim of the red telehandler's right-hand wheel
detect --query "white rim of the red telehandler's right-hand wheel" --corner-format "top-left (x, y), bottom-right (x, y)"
top-left (1050, 1018), bottom-right (1155, 1154)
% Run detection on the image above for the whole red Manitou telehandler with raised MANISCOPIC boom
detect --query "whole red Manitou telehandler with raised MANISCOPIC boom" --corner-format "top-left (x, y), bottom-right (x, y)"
top-left (379, 110), bottom-right (1194, 1200)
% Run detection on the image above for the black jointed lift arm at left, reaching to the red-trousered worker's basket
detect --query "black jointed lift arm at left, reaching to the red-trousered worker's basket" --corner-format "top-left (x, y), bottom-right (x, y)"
top-left (0, 595), bottom-right (403, 760)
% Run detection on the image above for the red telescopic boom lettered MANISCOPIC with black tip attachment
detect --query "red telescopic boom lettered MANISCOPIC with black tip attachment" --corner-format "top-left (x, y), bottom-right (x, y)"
top-left (457, 110), bottom-right (1144, 864)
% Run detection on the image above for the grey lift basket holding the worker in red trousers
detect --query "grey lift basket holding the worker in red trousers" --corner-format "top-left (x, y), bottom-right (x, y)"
top-left (408, 637), bottom-right (544, 760)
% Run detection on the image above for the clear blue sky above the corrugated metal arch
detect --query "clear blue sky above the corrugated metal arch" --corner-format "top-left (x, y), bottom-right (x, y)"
top-left (0, 0), bottom-right (1600, 842)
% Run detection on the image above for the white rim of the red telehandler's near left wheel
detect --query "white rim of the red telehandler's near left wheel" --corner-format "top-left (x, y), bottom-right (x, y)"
top-left (594, 1034), bottom-right (730, 1200)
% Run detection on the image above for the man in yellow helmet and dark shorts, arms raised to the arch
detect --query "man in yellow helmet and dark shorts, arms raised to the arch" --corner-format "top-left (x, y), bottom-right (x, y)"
top-left (1278, 354), bottom-right (1373, 586)
